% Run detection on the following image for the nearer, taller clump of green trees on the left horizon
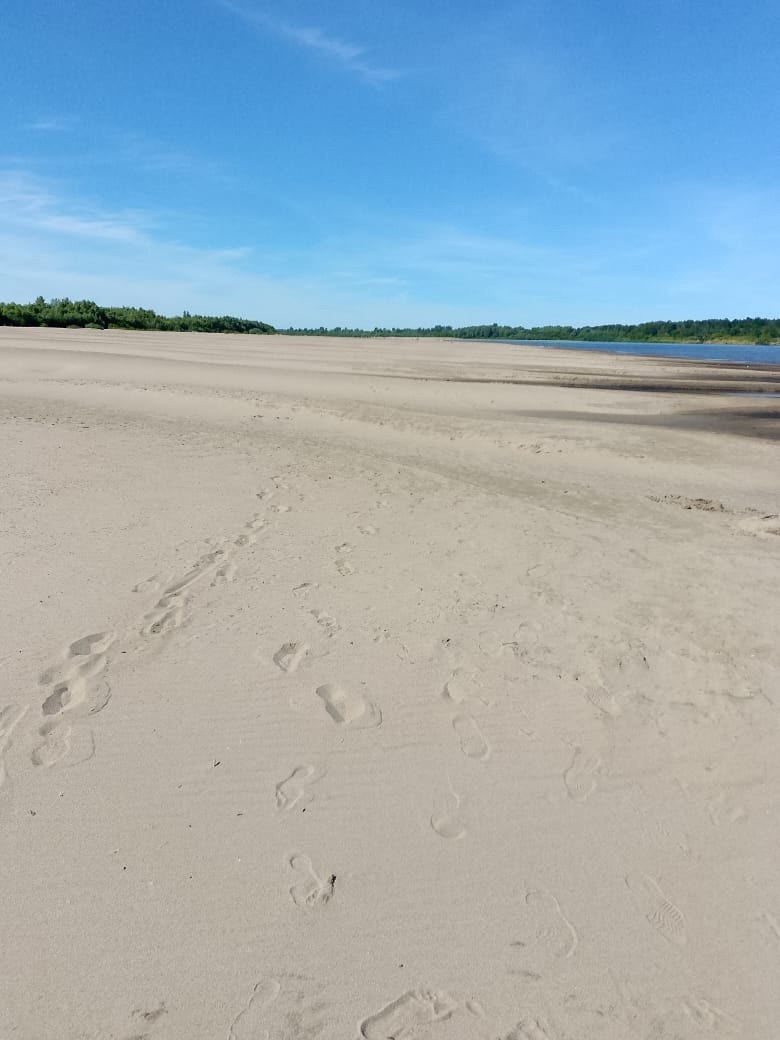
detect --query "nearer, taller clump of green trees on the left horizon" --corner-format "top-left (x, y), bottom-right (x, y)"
top-left (0, 296), bottom-right (276, 333)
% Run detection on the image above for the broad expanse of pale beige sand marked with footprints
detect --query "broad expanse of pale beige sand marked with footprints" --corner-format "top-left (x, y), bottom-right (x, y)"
top-left (0, 330), bottom-right (780, 1040)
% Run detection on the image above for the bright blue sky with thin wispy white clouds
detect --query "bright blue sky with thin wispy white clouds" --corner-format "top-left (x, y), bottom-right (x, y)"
top-left (0, 0), bottom-right (780, 328)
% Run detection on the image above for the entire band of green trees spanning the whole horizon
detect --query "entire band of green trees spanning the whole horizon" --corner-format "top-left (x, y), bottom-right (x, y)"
top-left (0, 296), bottom-right (780, 344)
